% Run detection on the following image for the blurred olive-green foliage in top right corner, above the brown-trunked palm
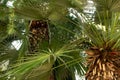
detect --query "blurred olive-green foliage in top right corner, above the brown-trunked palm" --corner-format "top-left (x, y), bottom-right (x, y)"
top-left (93, 0), bottom-right (120, 26)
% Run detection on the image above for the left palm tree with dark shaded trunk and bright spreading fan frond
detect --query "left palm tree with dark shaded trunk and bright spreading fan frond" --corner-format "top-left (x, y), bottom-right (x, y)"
top-left (0, 0), bottom-right (85, 80)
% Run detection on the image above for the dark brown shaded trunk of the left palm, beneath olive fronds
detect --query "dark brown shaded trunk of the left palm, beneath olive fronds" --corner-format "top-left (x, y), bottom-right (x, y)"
top-left (29, 20), bottom-right (49, 52)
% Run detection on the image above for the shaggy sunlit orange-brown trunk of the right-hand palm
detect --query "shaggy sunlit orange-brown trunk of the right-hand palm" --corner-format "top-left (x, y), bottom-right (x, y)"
top-left (86, 47), bottom-right (120, 80)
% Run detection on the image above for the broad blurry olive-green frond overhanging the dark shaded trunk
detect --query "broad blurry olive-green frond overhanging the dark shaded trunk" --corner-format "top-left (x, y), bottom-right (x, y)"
top-left (14, 0), bottom-right (85, 21)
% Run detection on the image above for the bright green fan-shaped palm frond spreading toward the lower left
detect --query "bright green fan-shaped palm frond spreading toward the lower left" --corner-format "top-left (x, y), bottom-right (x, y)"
top-left (2, 40), bottom-right (85, 78)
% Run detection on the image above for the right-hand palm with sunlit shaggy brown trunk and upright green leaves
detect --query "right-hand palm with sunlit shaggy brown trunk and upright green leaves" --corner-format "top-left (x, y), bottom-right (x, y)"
top-left (85, 0), bottom-right (120, 80)
